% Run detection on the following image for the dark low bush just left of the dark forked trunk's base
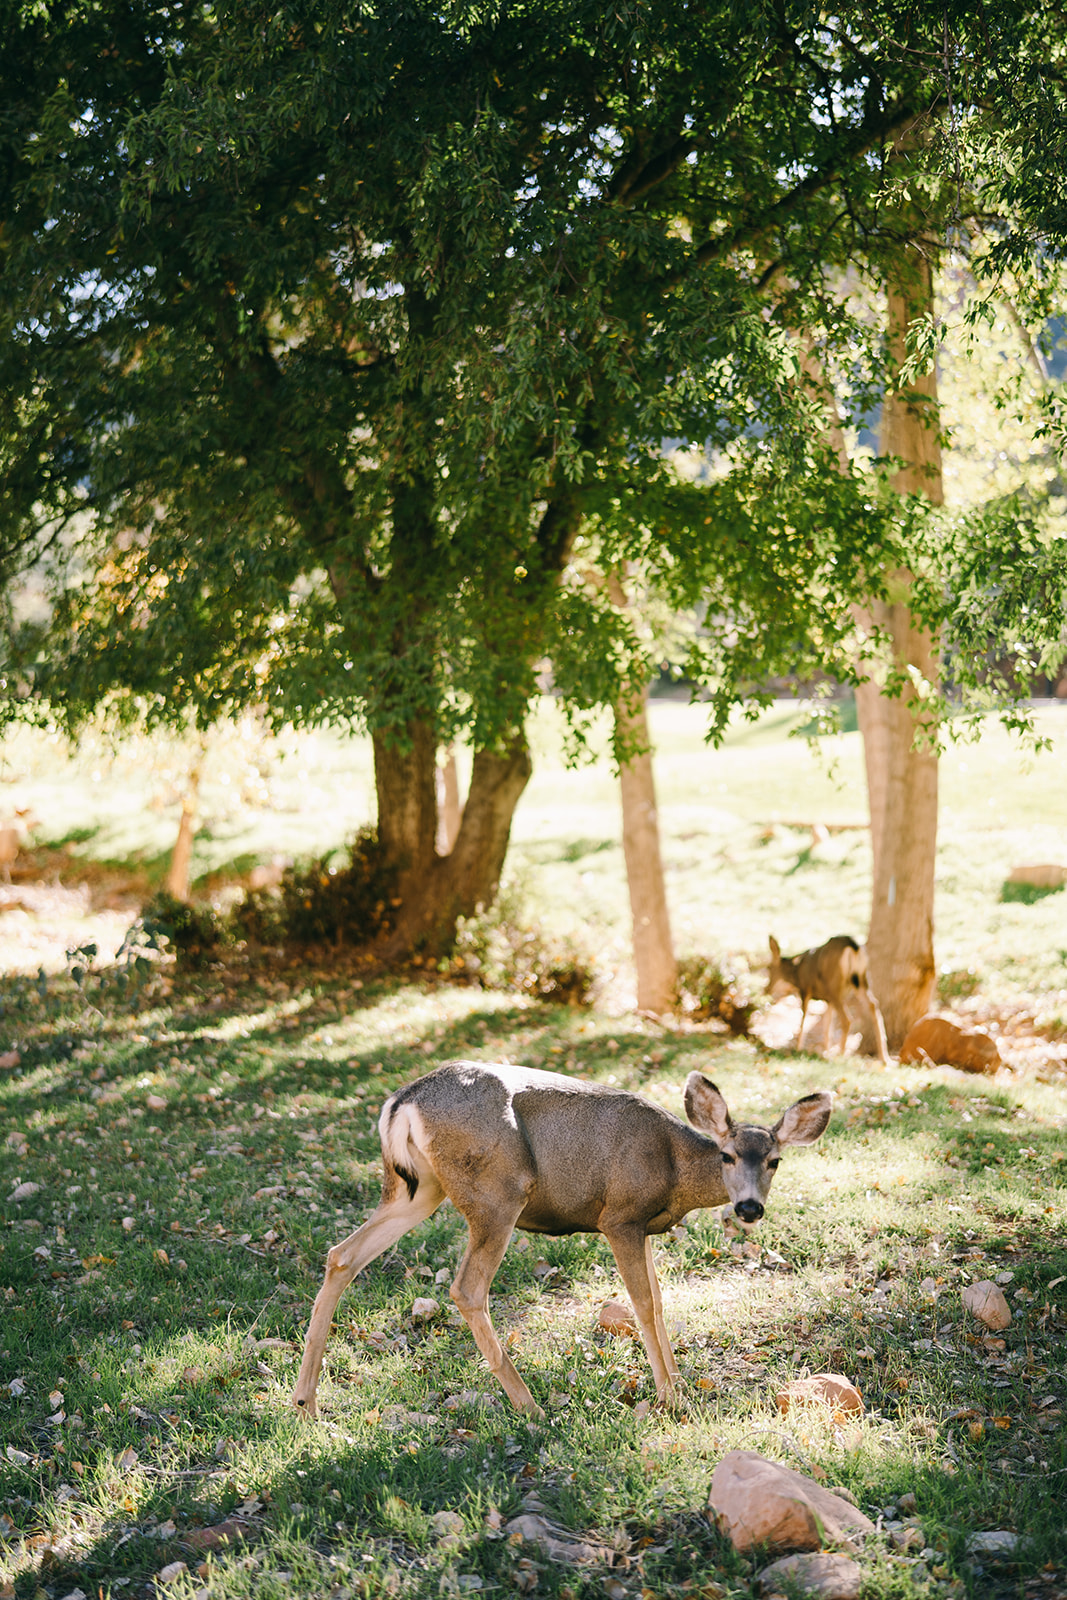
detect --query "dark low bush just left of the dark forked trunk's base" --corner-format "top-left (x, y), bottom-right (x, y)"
top-left (230, 827), bottom-right (397, 946)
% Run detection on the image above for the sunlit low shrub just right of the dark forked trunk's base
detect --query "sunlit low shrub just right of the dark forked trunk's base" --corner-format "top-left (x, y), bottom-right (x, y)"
top-left (446, 878), bottom-right (597, 1006)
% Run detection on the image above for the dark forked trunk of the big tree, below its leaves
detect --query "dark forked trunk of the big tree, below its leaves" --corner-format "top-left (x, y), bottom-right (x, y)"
top-left (374, 725), bottom-right (531, 955)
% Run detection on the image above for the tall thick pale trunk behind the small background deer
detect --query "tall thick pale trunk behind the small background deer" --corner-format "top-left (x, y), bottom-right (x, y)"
top-left (856, 250), bottom-right (942, 1050)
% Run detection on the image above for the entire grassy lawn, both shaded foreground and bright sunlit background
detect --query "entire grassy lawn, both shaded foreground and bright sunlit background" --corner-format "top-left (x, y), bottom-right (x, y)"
top-left (0, 702), bottom-right (1067, 1600)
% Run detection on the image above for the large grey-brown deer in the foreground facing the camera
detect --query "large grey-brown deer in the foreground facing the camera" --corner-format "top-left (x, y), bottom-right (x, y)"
top-left (293, 1061), bottom-right (833, 1418)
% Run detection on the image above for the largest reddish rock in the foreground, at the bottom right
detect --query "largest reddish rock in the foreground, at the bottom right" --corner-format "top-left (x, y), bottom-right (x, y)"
top-left (707, 1450), bottom-right (873, 1550)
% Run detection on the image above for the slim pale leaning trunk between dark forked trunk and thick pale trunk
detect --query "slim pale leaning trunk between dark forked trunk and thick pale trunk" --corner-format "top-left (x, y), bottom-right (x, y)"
top-left (608, 573), bottom-right (678, 1014)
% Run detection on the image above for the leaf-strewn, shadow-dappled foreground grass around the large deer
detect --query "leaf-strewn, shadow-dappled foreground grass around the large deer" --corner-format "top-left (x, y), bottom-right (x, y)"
top-left (0, 965), bottom-right (1067, 1600)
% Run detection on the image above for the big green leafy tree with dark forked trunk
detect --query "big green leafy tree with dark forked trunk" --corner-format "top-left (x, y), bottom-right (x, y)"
top-left (0, 0), bottom-right (1067, 972)
